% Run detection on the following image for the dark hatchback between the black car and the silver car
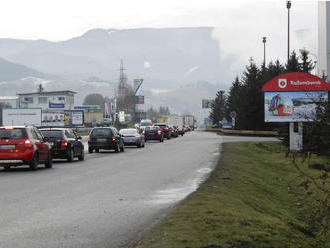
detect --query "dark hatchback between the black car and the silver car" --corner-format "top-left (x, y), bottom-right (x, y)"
top-left (88, 127), bottom-right (124, 153)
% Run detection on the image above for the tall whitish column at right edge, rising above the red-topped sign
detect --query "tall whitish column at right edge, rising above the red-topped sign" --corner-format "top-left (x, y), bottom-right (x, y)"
top-left (317, 1), bottom-right (330, 79)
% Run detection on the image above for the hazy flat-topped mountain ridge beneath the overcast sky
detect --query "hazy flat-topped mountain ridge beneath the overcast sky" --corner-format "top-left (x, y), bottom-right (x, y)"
top-left (0, 27), bottom-right (226, 88)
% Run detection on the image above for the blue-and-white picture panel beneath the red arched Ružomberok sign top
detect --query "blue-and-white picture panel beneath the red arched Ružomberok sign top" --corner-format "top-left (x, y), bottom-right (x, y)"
top-left (265, 91), bottom-right (328, 122)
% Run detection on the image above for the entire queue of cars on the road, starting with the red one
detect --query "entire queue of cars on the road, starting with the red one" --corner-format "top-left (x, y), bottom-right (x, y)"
top-left (0, 121), bottom-right (192, 170)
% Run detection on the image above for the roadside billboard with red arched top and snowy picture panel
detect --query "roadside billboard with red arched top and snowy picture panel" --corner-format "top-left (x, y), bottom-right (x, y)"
top-left (262, 72), bottom-right (330, 122)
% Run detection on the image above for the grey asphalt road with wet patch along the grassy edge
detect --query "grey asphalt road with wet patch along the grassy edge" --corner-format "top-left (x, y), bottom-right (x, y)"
top-left (0, 131), bottom-right (274, 248)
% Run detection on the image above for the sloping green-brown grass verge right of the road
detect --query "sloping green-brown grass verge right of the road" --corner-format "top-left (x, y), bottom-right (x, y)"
top-left (134, 142), bottom-right (330, 248)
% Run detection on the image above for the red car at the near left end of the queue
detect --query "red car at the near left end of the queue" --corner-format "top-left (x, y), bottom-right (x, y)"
top-left (0, 126), bottom-right (52, 170)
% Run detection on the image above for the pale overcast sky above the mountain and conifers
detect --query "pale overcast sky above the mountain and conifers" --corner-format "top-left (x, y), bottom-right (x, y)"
top-left (0, 0), bottom-right (317, 76)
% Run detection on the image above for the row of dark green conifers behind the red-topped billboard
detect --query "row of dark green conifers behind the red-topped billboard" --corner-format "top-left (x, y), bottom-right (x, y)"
top-left (209, 49), bottom-right (315, 130)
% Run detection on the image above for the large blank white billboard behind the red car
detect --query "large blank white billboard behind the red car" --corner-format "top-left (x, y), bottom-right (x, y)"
top-left (2, 108), bottom-right (41, 126)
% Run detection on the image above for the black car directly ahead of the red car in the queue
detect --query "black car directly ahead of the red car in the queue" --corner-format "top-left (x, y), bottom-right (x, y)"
top-left (40, 128), bottom-right (85, 162)
